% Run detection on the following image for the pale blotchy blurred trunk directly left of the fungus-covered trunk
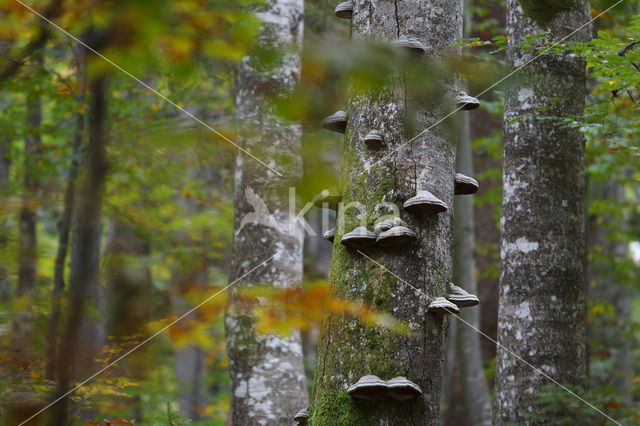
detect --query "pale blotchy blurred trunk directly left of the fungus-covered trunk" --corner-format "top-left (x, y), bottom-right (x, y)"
top-left (225, 0), bottom-right (308, 425)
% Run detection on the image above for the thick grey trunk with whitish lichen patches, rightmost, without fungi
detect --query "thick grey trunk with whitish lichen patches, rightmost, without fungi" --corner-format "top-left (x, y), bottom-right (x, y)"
top-left (494, 0), bottom-right (590, 424)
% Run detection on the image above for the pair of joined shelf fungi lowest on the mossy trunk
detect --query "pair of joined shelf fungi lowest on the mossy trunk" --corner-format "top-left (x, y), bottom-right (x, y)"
top-left (347, 375), bottom-right (422, 401)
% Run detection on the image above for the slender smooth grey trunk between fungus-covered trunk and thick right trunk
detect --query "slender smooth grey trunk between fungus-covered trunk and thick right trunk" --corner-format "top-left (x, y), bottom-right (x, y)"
top-left (453, 110), bottom-right (492, 425)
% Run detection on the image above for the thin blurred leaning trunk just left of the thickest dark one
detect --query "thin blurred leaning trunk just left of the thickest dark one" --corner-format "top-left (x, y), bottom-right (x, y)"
top-left (46, 48), bottom-right (86, 380)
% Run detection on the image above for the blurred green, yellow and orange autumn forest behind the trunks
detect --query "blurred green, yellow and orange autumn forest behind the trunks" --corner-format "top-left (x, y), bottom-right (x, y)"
top-left (0, 0), bottom-right (640, 425)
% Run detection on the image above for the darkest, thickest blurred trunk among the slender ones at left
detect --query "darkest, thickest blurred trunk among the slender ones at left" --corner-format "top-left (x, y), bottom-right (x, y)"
top-left (51, 72), bottom-right (108, 425)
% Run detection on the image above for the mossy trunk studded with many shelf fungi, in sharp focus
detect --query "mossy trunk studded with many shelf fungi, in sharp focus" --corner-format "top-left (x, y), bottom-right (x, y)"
top-left (312, 0), bottom-right (463, 425)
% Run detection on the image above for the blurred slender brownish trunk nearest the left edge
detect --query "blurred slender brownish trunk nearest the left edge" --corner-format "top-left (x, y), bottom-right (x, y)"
top-left (11, 55), bottom-right (42, 365)
